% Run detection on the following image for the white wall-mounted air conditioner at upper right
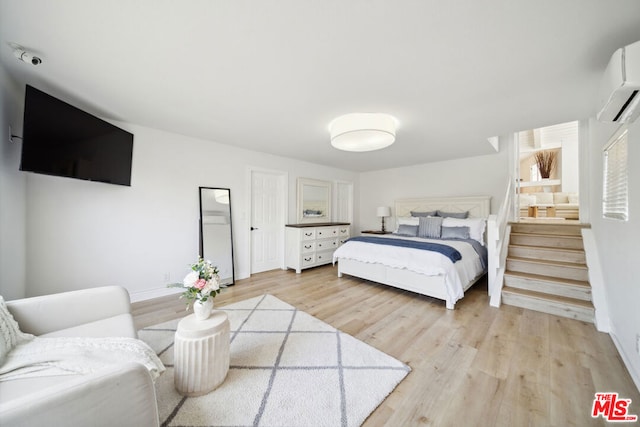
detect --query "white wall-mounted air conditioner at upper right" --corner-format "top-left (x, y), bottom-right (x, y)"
top-left (597, 41), bottom-right (640, 123)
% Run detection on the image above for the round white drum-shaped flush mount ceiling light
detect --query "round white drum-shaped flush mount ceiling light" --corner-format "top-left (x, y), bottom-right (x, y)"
top-left (329, 113), bottom-right (397, 152)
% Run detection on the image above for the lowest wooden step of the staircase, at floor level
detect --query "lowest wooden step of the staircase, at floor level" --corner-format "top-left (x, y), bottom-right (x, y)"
top-left (502, 287), bottom-right (595, 323)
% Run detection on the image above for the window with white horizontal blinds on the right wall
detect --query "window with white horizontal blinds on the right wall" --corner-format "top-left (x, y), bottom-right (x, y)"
top-left (602, 128), bottom-right (629, 221)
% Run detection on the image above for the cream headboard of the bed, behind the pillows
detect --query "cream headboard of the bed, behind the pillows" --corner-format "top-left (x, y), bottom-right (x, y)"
top-left (395, 196), bottom-right (491, 218)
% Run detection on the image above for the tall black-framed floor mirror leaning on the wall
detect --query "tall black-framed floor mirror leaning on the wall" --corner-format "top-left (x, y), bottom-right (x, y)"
top-left (199, 187), bottom-right (234, 286)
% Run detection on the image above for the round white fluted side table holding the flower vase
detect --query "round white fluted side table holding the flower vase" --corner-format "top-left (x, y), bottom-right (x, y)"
top-left (173, 310), bottom-right (229, 396)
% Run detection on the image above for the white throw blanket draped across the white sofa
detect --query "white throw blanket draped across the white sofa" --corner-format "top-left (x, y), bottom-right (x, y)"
top-left (0, 337), bottom-right (165, 381)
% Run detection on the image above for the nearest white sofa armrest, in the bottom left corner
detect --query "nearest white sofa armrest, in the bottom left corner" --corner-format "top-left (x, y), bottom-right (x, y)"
top-left (0, 363), bottom-right (159, 427)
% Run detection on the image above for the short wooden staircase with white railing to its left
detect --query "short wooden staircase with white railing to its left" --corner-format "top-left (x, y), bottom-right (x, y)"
top-left (502, 223), bottom-right (595, 323)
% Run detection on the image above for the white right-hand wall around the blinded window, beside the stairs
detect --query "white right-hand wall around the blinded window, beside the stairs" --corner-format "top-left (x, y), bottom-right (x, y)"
top-left (588, 120), bottom-right (640, 389)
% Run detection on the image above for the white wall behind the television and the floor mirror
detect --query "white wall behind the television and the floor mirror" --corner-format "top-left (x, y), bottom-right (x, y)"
top-left (21, 123), bottom-right (357, 299)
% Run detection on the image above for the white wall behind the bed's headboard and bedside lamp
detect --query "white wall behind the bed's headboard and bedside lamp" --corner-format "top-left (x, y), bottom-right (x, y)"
top-left (359, 147), bottom-right (509, 230)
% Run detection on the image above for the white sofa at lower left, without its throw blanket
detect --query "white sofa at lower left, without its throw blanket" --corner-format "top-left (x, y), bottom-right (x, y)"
top-left (0, 286), bottom-right (159, 427)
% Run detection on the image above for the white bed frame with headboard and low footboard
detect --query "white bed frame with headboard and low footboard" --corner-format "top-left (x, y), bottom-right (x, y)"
top-left (338, 196), bottom-right (492, 310)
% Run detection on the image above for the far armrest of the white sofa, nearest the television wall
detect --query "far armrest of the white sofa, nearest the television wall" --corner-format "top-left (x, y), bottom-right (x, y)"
top-left (7, 286), bottom-right (131, 335)
